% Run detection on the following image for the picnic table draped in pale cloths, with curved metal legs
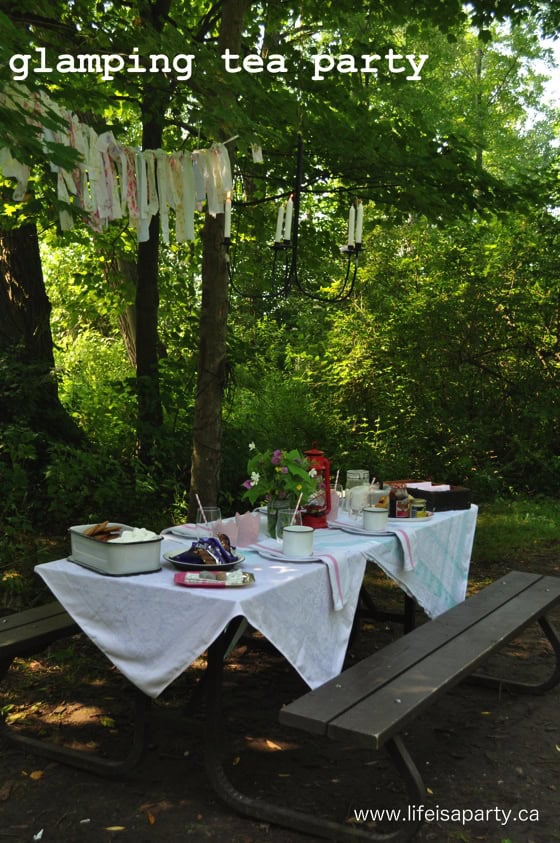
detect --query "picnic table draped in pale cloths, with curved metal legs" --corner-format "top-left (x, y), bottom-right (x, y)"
top-left (3, 505), bottom-right (494, 839)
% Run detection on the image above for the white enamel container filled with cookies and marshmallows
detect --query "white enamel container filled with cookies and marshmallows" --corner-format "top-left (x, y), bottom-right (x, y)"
top-left (69, 521), bottom-right (163, 577)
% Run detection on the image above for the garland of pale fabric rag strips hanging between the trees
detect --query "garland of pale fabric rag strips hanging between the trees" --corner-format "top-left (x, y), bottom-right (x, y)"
top-left (0, 94), bottom-right (233, 243)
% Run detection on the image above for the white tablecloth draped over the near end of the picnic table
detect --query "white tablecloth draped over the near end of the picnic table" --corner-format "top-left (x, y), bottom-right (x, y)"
top-left (35, 531), bottom-right (368, 697)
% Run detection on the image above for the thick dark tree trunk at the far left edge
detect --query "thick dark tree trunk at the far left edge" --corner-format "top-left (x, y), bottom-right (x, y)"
top-left (0, 219), bottom-right (83, 443)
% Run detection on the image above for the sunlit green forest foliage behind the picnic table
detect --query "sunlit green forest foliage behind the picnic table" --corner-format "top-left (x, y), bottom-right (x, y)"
top-left (0, 0), bottom-right (560, 572)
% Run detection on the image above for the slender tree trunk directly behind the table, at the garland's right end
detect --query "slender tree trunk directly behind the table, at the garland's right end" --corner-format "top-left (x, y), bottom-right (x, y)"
top-left (189, 0), bottom-right (251, 518)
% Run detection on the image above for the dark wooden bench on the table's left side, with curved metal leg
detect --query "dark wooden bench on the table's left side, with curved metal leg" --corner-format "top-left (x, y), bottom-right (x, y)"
top-left (0, 600), bottom-right (147, 776)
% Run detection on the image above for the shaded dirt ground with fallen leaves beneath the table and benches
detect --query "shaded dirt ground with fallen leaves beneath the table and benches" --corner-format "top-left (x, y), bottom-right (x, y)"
top-left (0, 542), bottom-right (560, 843)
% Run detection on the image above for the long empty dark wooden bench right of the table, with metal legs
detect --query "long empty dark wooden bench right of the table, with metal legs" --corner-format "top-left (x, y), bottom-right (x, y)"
top-left (206, 571), bottom-right (560, 843)
